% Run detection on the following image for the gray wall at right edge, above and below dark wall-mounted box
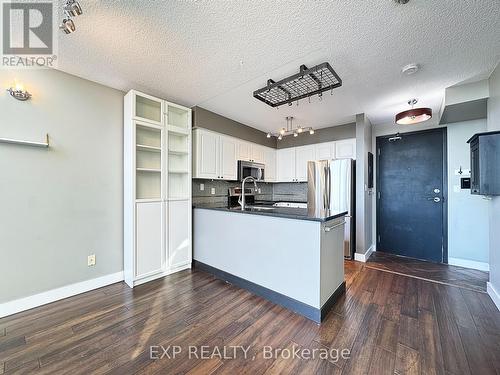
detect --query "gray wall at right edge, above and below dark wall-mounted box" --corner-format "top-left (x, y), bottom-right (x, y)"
top-left (488, 64), bottom-right (500, 293)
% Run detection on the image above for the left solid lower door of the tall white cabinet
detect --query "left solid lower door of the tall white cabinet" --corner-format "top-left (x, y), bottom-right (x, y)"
top-left (135, 202), bottom-right (165, 279)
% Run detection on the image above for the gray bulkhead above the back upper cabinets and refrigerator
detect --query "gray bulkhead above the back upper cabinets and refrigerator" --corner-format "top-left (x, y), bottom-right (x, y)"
top-left (277, 122), bottom-right (356, 148)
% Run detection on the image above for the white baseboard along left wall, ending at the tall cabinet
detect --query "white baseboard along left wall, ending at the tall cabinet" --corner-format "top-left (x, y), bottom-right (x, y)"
top-left (0, 271), bottom-right (123, 318)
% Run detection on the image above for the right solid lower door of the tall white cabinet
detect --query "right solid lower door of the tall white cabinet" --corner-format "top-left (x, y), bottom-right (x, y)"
top-left (168, 200), bottom-right (192, 268)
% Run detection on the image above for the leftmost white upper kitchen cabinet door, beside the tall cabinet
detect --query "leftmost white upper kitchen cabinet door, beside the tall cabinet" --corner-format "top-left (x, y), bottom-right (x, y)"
top-left (193, 130), bottom-right (220, 179)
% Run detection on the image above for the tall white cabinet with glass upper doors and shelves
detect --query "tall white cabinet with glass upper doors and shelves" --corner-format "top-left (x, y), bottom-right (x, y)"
top-left (123, 90), bottom-right (192, 288)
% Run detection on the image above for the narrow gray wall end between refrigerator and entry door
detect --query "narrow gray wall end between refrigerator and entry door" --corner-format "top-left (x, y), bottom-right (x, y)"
top-left (356, 114), bottom-right (373, 254)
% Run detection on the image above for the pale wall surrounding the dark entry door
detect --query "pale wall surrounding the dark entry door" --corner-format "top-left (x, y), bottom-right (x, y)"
top-left (373, 119), bottom-right (489, 269)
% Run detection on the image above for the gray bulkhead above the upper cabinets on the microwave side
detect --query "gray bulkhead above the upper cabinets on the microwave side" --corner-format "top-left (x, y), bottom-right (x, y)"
top-left (192, 107), bottom-right (276, 148)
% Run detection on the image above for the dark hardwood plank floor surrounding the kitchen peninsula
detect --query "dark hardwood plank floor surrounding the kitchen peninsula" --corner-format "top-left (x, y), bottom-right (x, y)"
top-left (0, 262), bottom-right (500, 375)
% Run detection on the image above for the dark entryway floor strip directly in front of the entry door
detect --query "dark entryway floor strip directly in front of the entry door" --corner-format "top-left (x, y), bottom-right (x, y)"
top-left (366, 251), bottom-right (489, 292)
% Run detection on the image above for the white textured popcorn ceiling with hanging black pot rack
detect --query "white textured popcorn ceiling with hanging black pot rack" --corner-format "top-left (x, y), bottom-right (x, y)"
top-left (54, 0), bottom-right (500, 130)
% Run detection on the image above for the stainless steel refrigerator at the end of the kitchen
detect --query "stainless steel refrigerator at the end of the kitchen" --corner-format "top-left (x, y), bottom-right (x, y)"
top-left (307, 159), bottom-right (356, 259)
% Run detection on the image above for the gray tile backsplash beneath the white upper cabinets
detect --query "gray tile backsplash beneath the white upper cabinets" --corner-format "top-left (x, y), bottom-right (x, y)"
top-left (192, 179), bottom-right (307, 205)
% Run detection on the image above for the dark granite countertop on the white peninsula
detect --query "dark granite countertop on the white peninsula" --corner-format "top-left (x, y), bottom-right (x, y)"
top-left (193, 204), bottom-right (347, 223)
